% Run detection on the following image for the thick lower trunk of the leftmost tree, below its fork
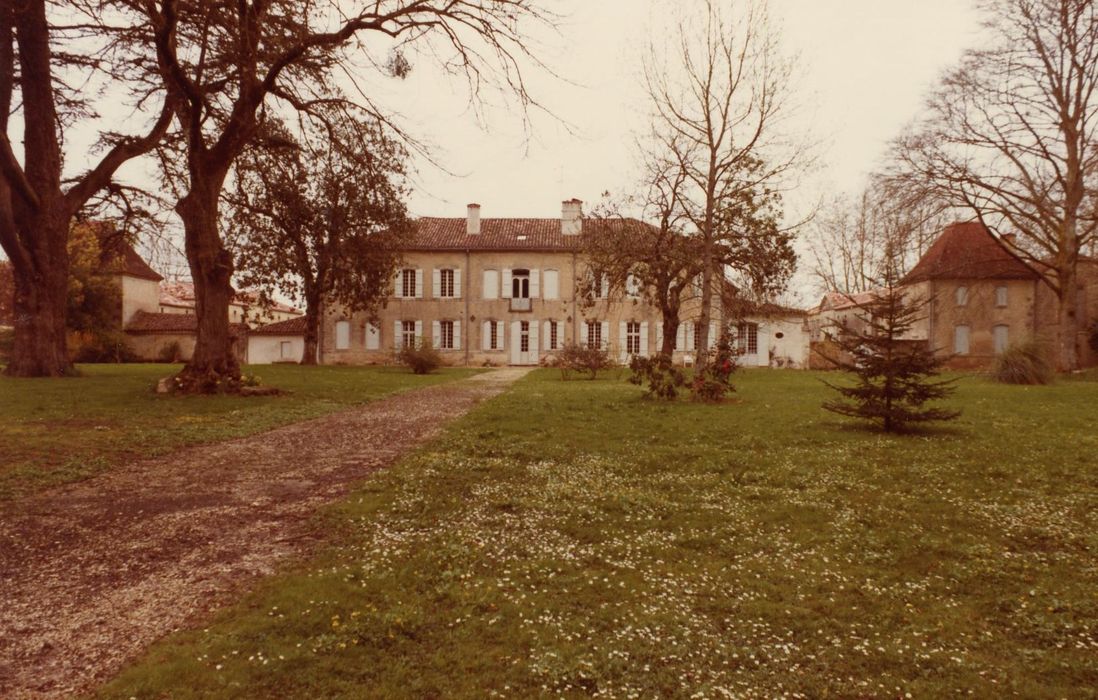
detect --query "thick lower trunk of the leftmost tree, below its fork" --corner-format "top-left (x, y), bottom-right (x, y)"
top-left (5, 222), bottom-right (75, 376)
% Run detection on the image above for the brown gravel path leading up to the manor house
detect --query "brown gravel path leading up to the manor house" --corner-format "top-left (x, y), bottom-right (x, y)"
top-left (0, 369), bottom-right (526, 698)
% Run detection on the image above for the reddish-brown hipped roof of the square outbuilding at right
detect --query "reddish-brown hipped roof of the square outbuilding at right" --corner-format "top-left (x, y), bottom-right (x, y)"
top-left (900, 222), bottom-right (1038, 284)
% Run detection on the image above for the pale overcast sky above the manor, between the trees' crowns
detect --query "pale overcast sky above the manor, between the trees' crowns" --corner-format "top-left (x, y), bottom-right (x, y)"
top-left (389, 0), bottom-right (977, 217)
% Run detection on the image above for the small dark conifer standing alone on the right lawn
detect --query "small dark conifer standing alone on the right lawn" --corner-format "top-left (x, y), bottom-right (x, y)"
top-left (824, 274), bottom-right (961, 432)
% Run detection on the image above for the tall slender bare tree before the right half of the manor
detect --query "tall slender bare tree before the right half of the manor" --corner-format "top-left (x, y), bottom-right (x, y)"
top-left (645, 0), bottom-right (805, 373)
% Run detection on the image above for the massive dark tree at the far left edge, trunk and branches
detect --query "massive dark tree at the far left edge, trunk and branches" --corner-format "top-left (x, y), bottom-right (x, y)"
top-left (0, 0), bottom-right (171, 376)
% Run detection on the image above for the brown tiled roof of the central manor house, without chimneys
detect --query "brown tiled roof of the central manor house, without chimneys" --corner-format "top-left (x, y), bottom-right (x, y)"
top-left (404, 216), bottom-right (581, 252)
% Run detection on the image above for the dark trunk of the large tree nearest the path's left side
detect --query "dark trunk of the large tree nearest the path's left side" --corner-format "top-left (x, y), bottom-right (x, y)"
top-left (176, 186), bottom-right (240, 394)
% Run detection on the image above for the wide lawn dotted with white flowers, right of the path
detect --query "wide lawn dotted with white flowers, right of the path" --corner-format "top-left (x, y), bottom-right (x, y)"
top-left (101, 371), bottom-right (1098, 698)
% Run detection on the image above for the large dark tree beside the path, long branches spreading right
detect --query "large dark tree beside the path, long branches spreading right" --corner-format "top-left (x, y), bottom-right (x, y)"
top-left (127, 0), bottom-right (551, 392)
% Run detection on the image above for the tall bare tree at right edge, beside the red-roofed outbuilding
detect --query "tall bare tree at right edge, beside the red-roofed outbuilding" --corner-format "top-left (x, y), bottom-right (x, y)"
top-left (893, 0), bottom-right (1098, 370)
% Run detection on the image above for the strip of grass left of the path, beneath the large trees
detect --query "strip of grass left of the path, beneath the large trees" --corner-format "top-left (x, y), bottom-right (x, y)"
top-left (0, 364), bottom-right (473, 500)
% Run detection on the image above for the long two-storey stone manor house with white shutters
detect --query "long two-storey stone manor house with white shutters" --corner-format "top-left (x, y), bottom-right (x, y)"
top-left (314, 200), bottom-right (808, 366)
